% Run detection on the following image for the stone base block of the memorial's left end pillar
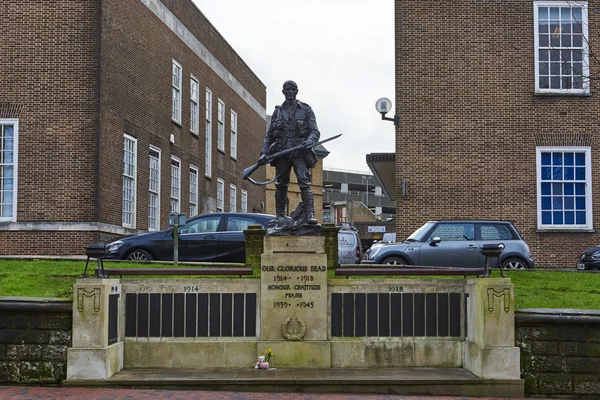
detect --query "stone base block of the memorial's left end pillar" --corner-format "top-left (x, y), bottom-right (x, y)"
top-left (67, 342), bottom-right (123, 380)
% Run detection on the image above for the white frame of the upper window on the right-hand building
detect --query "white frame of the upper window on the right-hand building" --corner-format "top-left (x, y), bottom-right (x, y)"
top-left (533, 1), bottom-right (590, 94)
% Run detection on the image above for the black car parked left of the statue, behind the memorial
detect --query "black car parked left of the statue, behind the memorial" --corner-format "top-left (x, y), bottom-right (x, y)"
top-left (106, 213), bottom-right (275, 263)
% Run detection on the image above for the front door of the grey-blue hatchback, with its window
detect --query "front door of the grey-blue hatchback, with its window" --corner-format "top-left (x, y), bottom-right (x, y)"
top-left (419, 222), bottom-right (481, 268)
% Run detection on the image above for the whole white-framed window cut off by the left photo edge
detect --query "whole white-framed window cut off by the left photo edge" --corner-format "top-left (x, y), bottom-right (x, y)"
top-left (0, 119), bottom-right (19, 222)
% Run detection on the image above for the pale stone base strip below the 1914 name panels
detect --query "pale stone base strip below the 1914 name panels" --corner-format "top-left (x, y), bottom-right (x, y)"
top-left (125, 341), bottom-right (256, 369)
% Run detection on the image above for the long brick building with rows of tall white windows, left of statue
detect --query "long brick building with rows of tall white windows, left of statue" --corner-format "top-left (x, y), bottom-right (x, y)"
top-left (0, 0), bottom-right (266, 254)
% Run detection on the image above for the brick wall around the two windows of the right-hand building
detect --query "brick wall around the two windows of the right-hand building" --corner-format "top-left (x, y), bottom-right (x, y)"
top-left (395, 0), bottom-right (600, 267)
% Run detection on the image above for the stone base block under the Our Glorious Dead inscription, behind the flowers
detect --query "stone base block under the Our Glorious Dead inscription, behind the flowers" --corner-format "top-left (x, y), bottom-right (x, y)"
top-left (256, 341), bottom-right (331, 368)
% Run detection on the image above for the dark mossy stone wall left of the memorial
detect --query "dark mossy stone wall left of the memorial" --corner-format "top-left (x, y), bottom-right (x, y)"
top-left (0, 297), bottom-right (72, 384)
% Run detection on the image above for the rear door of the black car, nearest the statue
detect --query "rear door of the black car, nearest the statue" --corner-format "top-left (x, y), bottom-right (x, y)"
top-left (216, 214), bottom-right (264, 263)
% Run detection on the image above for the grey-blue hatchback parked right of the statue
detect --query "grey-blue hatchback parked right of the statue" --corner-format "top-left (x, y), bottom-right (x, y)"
top-left (362, 220), bottom-right (534, 269)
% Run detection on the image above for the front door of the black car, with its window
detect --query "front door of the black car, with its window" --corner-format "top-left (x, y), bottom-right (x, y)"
top-left (179, 214), bottom-right (223, 261)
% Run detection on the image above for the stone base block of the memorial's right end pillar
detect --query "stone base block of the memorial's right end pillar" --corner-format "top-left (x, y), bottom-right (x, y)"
top-left (463, 342), bottom-right (521, 379)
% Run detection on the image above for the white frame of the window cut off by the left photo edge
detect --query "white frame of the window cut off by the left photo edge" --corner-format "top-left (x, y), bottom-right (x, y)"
top-left (0, 118), bottom-right (19, 222)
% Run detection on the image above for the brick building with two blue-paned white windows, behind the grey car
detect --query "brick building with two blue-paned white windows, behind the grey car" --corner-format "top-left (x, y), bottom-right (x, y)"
top-left (367, 0), bottom-right (600, 268)
